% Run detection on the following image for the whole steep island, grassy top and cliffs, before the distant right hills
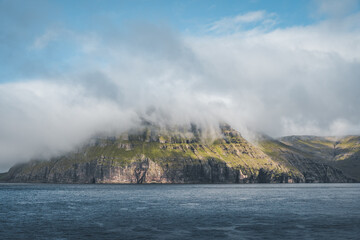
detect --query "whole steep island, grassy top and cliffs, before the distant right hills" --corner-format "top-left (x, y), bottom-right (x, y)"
top-left (0, 125), bottom-right (352, 183)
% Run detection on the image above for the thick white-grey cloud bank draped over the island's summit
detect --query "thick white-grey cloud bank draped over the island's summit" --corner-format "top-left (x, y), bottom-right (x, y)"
top-left (0, 1), bottom-right (360, 170)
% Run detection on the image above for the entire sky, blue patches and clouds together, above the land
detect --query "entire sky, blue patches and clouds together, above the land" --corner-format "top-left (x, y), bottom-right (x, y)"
top-left (0, 0), bottom-right (360, 172)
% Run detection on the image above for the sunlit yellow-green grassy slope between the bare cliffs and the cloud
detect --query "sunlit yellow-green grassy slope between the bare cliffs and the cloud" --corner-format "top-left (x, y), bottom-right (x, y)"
top-left (4, 126), bottom-right (298, 181)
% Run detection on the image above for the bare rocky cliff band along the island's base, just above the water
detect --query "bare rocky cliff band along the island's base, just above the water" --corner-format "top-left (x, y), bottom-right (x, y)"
top-left (2, 157), bottom-right (301, 183)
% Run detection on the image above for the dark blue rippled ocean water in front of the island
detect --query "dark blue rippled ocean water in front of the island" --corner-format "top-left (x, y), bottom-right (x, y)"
top-left (0, 184), bottom-right (360, 239)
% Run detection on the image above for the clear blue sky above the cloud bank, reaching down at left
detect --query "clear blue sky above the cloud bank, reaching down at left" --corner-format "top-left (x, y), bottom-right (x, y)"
top-left (0, 0), bottom-right (348, 82)
